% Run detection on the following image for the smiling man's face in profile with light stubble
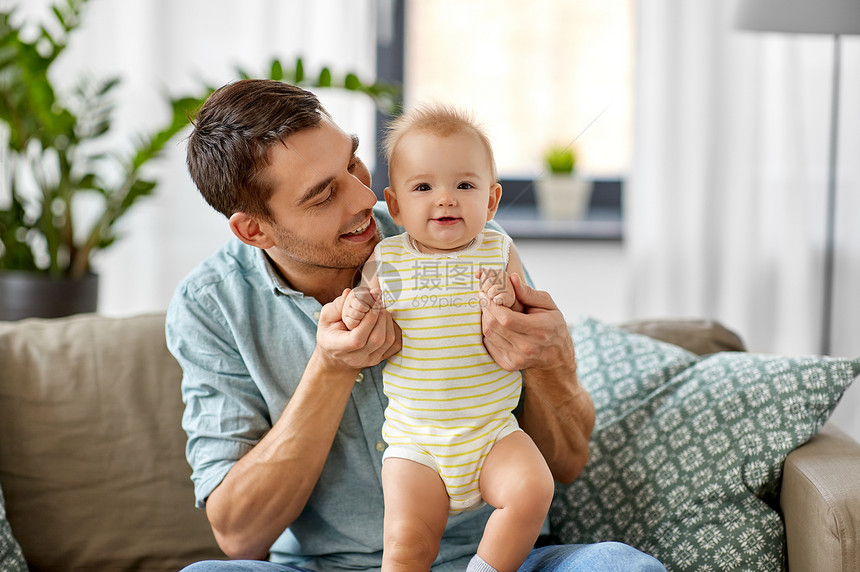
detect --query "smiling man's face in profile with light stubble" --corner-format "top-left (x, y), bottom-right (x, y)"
top-left (261, 118), bottom-right (380, 274)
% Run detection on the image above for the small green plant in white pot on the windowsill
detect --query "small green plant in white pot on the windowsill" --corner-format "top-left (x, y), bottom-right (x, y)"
top-left (535, 145), bottom-right (592, 220)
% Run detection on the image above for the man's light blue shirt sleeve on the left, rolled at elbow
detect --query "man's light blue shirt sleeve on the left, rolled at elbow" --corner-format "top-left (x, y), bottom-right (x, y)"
top-left (165, 284), bottom-right (271, 508)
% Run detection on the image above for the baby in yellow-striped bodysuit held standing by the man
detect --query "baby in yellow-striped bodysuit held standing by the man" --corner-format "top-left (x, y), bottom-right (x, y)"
top-left (343, 106), bottom-right (553, 571)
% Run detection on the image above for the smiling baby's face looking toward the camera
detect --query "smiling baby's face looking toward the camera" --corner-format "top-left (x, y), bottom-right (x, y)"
top-left (385, 131), bottom-right (502, 252)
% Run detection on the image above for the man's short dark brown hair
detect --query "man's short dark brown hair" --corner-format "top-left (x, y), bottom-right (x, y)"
top-left (186, 79), bottom-right (331, 220)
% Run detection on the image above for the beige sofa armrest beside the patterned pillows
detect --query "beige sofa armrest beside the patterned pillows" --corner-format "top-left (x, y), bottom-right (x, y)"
top-left (780, 423), bottom-right (860, 572)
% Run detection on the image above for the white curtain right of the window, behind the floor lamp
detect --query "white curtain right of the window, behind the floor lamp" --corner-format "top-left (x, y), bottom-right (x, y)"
top-left (626, 0), bottom-right (860, 438)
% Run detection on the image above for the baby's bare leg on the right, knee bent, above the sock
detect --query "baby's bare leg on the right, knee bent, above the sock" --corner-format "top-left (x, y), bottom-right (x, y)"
top-left (478, 431), bottom-right (555, 572)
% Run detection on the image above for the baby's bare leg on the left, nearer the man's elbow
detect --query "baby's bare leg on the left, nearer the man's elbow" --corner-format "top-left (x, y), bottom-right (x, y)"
top-left (382, 457), bottom-right (448, 572)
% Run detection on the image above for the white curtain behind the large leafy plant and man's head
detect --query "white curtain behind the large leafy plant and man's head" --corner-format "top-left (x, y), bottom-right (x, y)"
top-left (0, 0), bottom-right (379, 315)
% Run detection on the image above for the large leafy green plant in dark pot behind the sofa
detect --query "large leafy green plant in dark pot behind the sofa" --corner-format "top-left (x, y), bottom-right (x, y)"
top-left (0, 0), bottom-right (398, 320)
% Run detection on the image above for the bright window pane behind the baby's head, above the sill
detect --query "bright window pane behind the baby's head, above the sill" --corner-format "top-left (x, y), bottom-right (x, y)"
top-left (403, 0), bottom-right (634, 179)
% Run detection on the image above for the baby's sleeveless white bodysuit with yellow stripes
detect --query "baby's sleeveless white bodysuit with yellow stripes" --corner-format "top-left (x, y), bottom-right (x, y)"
top-left (374, 230), bottom-right (522, 513)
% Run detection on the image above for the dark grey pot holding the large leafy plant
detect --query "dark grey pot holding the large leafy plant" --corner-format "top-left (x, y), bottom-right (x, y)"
top-left (0, 270), bottom-right (99, 321)
